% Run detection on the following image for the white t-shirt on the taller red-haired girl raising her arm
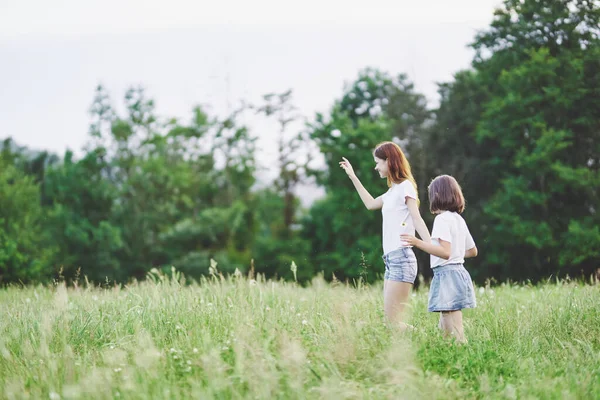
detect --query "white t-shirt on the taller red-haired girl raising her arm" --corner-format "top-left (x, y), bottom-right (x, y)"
top-left (380, 180), bottom-right (417, 254)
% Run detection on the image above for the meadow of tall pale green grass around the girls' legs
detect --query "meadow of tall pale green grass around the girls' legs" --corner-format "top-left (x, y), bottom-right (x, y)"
top-left (0, 268), bottom-right (600, 399)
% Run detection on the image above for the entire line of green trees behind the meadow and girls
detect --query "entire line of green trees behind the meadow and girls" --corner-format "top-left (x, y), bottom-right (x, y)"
top-left (0, 0), bottom-right (600, 284)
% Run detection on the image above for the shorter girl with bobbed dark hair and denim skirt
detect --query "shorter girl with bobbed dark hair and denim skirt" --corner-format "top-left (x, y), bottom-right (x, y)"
top-left (402, 175), bottom-right (477, 343)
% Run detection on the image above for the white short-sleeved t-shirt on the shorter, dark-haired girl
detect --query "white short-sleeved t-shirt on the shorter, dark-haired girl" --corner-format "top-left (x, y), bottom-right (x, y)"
top-left (430, 211), bottom-right (475, 268)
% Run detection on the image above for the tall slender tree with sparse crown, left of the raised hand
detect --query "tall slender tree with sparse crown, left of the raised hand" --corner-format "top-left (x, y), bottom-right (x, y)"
top-left (245, 90), bottom-right (314, 281)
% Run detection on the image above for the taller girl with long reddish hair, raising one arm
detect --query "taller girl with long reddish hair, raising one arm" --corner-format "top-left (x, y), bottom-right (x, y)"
top-left (340, 142), bottom-right (430, 330)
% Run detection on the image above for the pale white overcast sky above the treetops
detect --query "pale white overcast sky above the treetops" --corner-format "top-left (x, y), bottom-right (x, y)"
top-left (0, 0), bottom-right (500, 200)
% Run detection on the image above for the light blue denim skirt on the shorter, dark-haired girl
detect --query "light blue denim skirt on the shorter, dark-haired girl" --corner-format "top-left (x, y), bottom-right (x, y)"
top-left (427, 264), bottom-right (477, 312)
